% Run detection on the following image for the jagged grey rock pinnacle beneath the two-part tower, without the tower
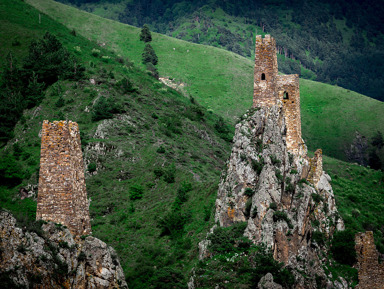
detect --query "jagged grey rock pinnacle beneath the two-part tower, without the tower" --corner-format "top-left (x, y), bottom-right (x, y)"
top-left (212, 104), bottom-right (344, 288)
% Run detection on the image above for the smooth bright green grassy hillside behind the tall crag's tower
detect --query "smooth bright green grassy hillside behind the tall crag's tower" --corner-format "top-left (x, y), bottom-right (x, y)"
top-left (27, 0), bottom-right (384, 160)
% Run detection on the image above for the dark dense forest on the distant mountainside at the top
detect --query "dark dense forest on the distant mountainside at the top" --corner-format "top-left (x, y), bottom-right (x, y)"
top-left (57, 0), bottom-right (384, 101)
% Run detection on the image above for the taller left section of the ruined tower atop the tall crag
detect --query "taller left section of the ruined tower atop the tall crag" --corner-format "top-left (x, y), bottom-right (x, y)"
top-left (253, 35), bottom-right (277, 107)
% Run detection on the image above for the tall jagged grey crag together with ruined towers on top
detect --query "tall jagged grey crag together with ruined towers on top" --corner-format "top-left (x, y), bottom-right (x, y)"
top-left (195, 35), bottom-right (348, 288)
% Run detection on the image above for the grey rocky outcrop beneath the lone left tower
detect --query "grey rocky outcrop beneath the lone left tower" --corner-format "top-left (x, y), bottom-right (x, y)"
top-left (0, 211), bottom-right (128, 289)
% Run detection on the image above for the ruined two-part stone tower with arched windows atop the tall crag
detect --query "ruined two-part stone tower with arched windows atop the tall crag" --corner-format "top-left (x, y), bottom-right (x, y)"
top-left (253, 35), bottom-right (303, 153)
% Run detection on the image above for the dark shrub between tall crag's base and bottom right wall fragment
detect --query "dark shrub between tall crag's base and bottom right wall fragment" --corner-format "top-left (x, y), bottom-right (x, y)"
top-left (331, 230), bottom-right (356, 266)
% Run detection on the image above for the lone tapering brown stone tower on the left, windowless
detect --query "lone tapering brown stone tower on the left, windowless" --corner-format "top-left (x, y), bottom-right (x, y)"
top-left (36, 120), bottom-right (91, 235)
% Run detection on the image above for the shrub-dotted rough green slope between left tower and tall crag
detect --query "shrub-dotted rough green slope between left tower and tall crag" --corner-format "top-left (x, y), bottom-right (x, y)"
top-left (0, 0), bottom-right (230, 288)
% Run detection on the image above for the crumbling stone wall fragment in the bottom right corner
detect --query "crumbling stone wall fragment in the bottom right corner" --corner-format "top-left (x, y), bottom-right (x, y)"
top-left (355, 231), bottom-right (384, 289)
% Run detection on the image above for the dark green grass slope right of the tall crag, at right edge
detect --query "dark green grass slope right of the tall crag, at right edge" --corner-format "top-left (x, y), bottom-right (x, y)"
top-left (323, 156), bottom-right (384, 253)
